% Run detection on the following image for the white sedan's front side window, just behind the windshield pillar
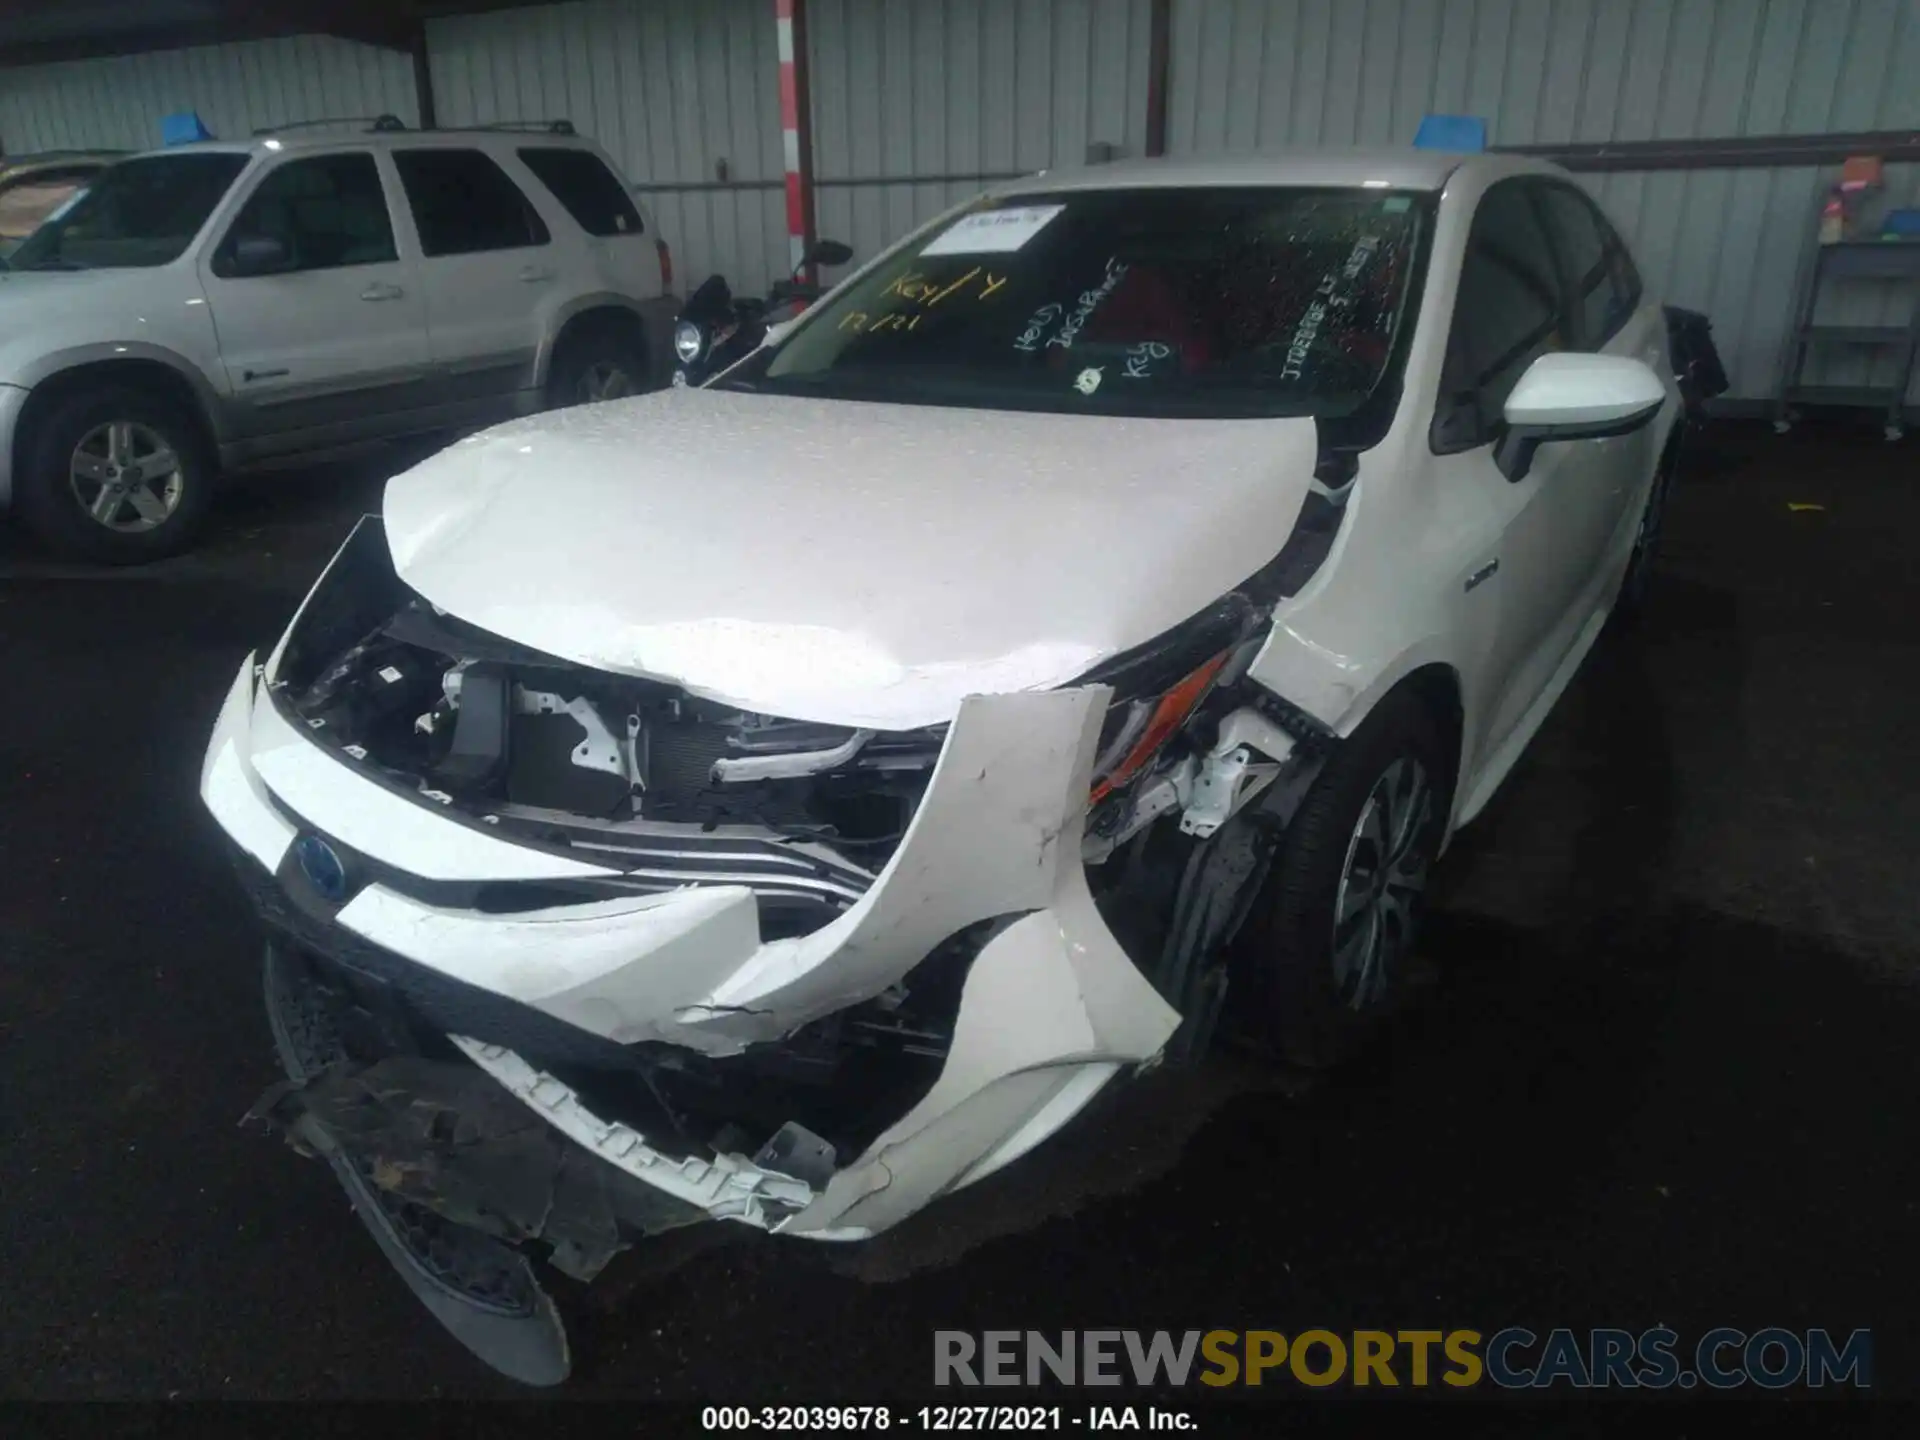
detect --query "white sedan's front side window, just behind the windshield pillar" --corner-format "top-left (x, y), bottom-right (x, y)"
top-left (1430, 180), bottom-right (1569, 455)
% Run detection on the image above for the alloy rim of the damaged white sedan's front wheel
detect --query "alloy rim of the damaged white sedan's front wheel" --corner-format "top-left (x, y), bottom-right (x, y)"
top-left (1332, 755), bottom-right (1434, 1010)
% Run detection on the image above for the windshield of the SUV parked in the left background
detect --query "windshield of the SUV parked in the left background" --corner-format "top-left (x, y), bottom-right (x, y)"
top-left (8, 152), bottom-right (248, 271)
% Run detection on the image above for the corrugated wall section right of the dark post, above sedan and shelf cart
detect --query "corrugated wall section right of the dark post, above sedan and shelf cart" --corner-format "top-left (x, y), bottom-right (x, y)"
top-left (1167, 0), bottom-right (1920, 397)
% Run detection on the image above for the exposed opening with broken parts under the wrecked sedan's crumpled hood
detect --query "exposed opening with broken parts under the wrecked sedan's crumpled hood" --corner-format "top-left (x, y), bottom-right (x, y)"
top-left (273, 522), bottom-right (943, 937)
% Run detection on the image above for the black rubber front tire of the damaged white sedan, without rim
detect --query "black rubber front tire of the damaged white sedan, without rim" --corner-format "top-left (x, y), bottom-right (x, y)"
top-left (1242, 689), bottom-right (1455, 1069)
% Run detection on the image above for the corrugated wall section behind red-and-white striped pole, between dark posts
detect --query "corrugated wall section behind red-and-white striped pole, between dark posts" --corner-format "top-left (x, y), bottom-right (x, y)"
top-left (428, 0), bottom-right (1148, 292)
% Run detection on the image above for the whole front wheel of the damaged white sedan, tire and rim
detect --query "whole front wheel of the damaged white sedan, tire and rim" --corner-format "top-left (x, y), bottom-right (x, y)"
top-left (1246, 691), bottom-right (1453, 1068)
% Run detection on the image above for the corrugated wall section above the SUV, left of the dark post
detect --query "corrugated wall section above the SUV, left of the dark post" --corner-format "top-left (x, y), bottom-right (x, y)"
top-left (0, 35), bottom-right (419, 156)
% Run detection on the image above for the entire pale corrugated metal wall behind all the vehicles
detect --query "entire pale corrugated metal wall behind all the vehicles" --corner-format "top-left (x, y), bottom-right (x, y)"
top-left (0, 0), bottom-right (1920, 407)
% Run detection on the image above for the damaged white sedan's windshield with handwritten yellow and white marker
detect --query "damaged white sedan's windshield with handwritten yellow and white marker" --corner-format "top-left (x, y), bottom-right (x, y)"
top-left (720, 186), bottom-right (1428, 419)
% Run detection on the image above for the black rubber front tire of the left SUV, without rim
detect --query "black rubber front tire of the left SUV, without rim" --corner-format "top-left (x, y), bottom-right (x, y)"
top-left (15, 384), bottom-right (217, 564)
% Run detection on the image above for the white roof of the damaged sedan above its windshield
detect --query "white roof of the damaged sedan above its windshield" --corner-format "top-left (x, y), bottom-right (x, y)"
top-left (993, 146), bottom-right (1561, 196)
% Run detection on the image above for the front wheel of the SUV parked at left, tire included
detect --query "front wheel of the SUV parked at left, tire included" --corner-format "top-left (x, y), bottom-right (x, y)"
top-left (19, 386), bottom-right (213, 564)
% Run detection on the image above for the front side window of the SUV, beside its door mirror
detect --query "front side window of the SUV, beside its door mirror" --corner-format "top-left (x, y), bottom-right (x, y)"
top-left (213, 152), bottom-right (399, 276)
